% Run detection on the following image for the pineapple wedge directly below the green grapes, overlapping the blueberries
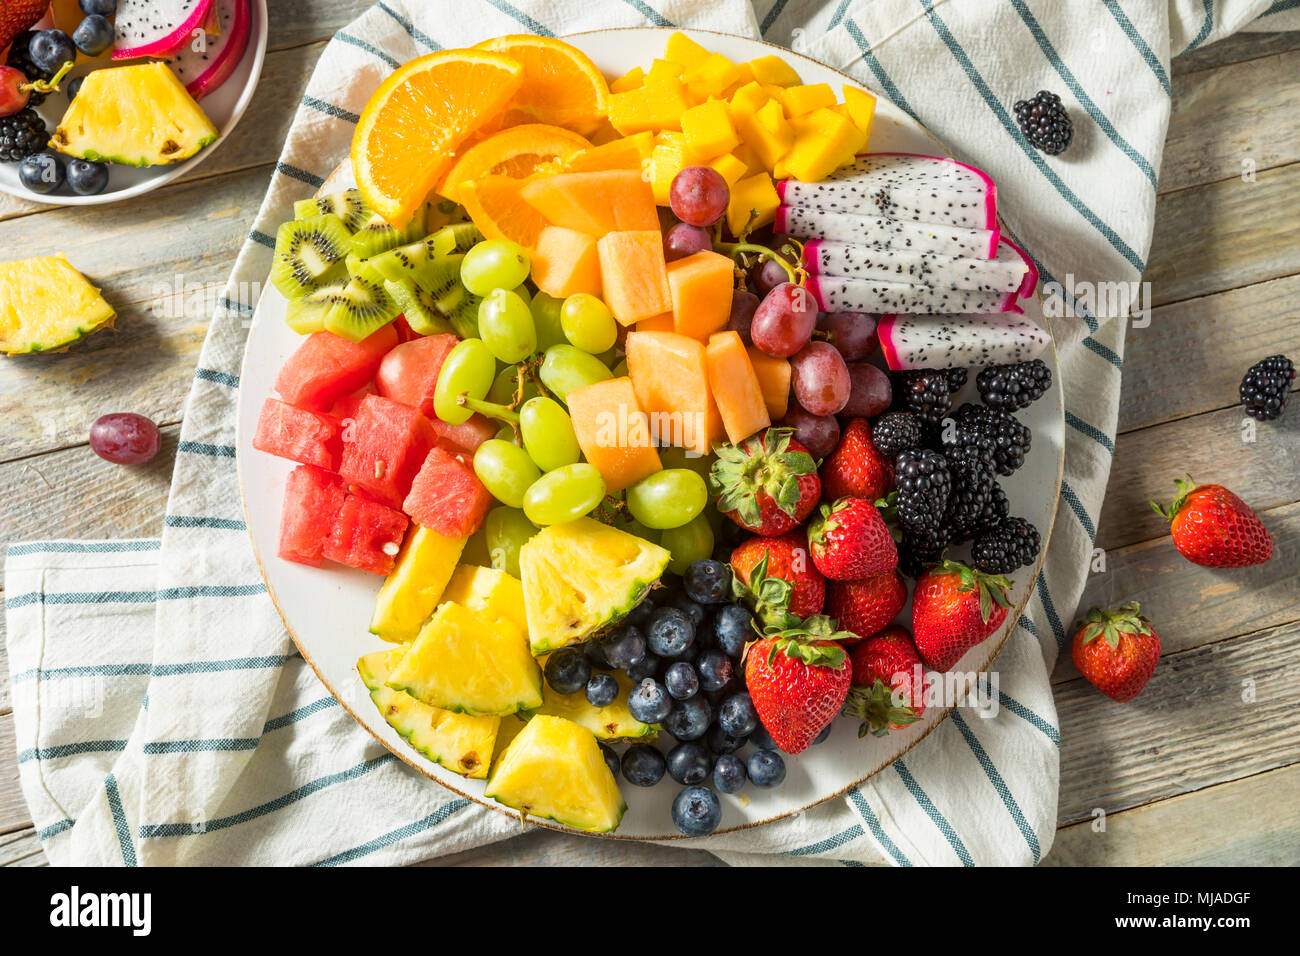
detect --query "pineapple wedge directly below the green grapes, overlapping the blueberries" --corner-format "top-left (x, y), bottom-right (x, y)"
top-left (519, 518), bottom-right (671, 656)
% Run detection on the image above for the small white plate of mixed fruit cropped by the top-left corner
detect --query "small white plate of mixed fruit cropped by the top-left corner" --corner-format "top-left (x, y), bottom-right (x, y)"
top-left (0, 0), bottom-right (267, 206)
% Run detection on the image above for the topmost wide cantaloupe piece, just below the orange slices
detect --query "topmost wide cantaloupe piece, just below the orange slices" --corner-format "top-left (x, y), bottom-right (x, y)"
top-left (520, 169), bottom-right (659, 238)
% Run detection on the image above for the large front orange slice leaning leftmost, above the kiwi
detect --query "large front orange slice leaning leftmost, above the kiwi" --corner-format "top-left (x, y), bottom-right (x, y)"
top-left (352, 49), bottom-right (524, 228)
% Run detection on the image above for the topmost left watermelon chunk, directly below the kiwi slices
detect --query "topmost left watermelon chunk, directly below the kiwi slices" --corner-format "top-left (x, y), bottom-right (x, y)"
top-left (276, 323), bottom-right (398, 411)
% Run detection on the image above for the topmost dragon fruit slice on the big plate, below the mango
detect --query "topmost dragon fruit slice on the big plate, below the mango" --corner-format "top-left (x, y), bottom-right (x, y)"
top-left (776, 152), bottom-right (997, 230)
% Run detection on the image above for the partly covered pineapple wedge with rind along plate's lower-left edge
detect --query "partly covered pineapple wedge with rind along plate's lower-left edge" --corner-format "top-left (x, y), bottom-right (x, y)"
top-left (356, 648), bottom-right (502, 780)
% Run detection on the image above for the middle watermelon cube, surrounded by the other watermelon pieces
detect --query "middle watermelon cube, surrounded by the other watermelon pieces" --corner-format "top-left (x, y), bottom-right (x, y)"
top-left (338, 395), bottom-right (438, 507)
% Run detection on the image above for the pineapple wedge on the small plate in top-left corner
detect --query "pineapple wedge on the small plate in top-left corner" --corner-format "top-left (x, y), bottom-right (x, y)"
top-left (49, 62), bottom-right (220, 166)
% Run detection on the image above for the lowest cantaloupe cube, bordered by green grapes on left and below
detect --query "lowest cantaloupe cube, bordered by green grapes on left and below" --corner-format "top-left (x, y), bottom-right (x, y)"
top-left (566, 378), bottom-right (663, 494)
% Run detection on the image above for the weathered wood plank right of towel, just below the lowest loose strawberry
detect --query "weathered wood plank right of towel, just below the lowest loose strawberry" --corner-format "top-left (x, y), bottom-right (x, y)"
top-left (1056, 622), bottom-right (1300, 825)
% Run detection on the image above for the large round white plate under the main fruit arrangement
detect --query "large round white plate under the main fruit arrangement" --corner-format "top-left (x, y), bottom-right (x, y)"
top-left (238, 29), bottom-right (1065, 840)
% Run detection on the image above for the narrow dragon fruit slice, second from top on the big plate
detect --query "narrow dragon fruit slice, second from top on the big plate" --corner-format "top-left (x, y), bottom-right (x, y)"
top-left (775, 206), bottom-right (1002, 259)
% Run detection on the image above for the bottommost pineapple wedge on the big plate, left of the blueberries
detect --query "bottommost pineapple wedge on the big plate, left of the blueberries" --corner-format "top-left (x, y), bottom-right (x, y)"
top-left (484, 715), bottom-right (628, 834)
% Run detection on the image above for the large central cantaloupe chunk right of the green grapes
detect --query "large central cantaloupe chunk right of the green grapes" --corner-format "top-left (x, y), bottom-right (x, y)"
top-left (627, 332), bottom-right (727, 455)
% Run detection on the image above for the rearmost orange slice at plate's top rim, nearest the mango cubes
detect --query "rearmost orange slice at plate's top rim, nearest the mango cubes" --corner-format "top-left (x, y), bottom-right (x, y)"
top-left (475, 34), bottom-right (610, 134)
